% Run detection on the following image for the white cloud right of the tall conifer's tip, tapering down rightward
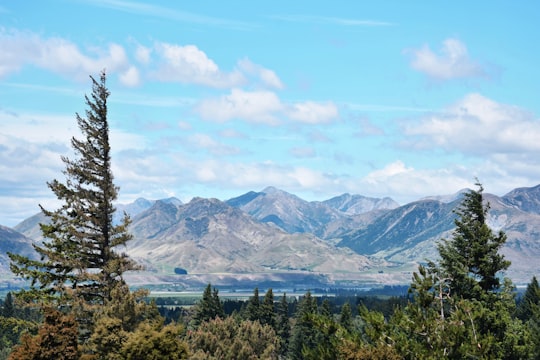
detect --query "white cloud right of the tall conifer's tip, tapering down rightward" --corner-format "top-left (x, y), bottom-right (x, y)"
top-left (155, 43), bottom-right (245, 88)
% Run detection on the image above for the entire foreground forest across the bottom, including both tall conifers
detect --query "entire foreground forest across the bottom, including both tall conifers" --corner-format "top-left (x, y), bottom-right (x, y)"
top-left (0, 72), bottom-right (540, 359)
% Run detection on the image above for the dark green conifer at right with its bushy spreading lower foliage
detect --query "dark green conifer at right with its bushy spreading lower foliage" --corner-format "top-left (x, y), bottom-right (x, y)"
top-left (356, 184), bottom-right (531, 359)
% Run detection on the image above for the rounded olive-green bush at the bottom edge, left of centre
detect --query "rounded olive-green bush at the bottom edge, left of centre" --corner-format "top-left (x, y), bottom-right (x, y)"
top-left (187, 316), bottom-right (279, 360)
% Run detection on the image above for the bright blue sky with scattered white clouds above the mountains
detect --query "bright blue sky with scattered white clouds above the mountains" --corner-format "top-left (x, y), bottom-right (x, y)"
top-left (0, 0), bottom-right (540, 226)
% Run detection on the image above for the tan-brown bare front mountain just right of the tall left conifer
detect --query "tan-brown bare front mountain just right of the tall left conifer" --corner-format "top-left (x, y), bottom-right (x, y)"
top-left (128, 198), bottom-right (376, 274)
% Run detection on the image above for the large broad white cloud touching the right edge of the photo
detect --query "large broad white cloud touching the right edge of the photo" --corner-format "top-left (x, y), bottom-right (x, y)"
top-left (404, 94), bottom-right (540, 157)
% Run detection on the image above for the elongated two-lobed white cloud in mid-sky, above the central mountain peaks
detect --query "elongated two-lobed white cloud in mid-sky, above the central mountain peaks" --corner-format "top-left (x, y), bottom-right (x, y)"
top-left (196, 89), bottom-right (338, 125)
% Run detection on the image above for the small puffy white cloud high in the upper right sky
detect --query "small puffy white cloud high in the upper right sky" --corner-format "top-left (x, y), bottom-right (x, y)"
top-left (407, 38), bottom-right (487, 80)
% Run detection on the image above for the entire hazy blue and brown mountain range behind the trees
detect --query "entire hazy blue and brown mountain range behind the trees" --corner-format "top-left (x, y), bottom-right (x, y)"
top-left (0, 185), bottom-right (540, 286)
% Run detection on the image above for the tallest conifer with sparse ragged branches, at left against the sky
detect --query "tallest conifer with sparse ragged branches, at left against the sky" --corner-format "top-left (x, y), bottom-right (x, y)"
top-left (9, 71), bottom-right (136, 312)
